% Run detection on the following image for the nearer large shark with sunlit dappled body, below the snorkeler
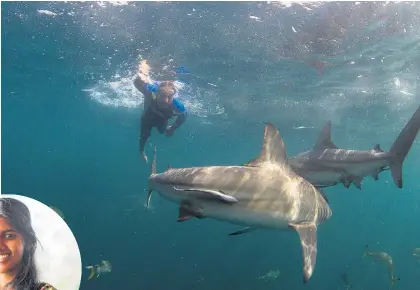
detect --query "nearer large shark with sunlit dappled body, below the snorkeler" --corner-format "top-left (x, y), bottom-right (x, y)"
top-left (147, 123), bottom-right (332, 283)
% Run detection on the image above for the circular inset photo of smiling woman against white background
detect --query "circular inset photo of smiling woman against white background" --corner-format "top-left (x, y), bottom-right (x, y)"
top-left (0, 194), bottom-right (82, 290)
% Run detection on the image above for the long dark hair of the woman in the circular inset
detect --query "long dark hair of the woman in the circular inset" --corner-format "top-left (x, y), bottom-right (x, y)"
top-left (0, 198), bottom-right (39, 290)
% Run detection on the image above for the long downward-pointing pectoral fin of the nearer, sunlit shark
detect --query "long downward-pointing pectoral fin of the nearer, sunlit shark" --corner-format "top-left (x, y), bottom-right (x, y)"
top-left (290, 224), bottom-right (317, 283)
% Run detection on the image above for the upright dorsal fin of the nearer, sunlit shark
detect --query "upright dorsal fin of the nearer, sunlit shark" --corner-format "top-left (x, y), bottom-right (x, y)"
top-left (243, 122), bottom-right (287, 167)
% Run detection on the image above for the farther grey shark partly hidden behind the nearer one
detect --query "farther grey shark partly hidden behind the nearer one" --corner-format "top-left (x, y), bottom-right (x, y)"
top-left (288, 107), bottom-right (420, 189)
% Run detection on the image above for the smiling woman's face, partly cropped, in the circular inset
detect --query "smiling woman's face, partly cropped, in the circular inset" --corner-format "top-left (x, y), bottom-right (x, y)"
top-left (0, 217), bottom-right (24, 273)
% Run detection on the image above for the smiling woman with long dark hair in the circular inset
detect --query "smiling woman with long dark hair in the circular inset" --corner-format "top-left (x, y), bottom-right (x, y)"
top-left (0, 198), bottom-right (56, 290)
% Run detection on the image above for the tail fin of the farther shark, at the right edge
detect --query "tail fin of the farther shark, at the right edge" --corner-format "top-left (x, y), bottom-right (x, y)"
top-left (389, 106), bottom-right (420, 188)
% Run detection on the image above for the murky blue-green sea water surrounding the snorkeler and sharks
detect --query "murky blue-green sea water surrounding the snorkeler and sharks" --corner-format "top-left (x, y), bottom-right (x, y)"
top-left (1, 2), bottom-right (420, 290)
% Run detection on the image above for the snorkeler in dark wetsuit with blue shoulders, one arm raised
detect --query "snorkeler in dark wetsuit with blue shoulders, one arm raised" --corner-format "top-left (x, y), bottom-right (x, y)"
top-left (134, 60), bottom-right (187, 162)
